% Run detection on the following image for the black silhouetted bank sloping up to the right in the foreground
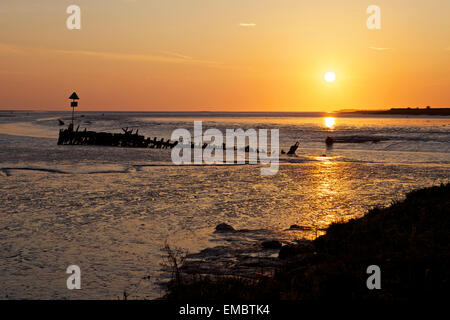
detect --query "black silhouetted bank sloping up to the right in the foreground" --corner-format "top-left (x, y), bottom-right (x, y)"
top-left (166, 184), bottom-right (450, 301)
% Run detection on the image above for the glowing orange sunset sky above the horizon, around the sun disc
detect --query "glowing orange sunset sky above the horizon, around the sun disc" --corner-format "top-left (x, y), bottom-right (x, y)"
top-left (0, 0), bottom-right (450, 112)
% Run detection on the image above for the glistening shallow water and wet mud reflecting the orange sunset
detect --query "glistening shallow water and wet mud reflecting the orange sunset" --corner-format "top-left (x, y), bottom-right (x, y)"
top-left (0, 112), bottom-right (450, 299)
